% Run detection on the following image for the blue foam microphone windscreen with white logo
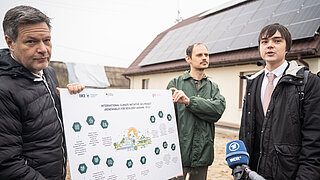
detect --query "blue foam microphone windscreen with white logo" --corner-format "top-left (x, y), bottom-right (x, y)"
top-left (226, 140), bottom-right (249, 168)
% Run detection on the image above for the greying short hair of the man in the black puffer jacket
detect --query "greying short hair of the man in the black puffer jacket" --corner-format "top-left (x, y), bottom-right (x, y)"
top-left (2, 6), bottom-right (51, 41)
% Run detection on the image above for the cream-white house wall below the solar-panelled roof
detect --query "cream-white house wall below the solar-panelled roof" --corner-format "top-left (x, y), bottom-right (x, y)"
top-left (130, 58), bottom-right (320, 126)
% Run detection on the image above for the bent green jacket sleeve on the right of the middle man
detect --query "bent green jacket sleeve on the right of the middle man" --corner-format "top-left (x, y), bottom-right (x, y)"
top-left (186, 83), bottom-right (226, 123)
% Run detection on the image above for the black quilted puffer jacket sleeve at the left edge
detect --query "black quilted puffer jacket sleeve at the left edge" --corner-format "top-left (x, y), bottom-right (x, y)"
top-left (0, 90), bottom-right (45, 180)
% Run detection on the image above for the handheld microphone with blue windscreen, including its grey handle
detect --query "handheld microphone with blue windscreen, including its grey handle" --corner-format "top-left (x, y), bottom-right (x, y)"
top-left (226, 140), bottom-right (265, 180)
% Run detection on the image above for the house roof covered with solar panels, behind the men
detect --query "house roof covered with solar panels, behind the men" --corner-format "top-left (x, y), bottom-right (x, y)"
top-left (124, 0), bottom-right (320, 75)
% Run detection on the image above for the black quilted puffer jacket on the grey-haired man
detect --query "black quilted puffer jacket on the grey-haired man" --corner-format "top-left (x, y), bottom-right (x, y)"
top-left (0, 49), bottom-right (66, 180)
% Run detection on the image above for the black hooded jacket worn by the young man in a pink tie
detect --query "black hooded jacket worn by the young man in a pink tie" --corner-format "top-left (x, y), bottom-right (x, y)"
top-left (239, 61), bottom-right (320, 180)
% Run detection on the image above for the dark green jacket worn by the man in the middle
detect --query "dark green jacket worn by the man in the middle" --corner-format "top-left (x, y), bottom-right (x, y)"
top-left (167, 71), bottom-right (226, 167)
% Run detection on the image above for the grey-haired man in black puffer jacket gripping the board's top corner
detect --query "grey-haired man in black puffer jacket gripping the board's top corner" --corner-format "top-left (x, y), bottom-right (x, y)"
top-left (0, 6), bottom-right (84, 180)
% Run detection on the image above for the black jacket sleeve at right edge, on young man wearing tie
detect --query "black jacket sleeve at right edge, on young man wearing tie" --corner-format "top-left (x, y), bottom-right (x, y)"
top-left (296, 73), bottom-right (320, 180)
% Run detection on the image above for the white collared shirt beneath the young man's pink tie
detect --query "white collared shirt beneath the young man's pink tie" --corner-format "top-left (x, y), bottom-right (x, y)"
top-left (261, 61), bottom-right (288, 102)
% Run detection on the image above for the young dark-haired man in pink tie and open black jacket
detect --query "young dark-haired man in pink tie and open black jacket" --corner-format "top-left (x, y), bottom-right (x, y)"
top-left (239, 23), bottom-right (320, 180)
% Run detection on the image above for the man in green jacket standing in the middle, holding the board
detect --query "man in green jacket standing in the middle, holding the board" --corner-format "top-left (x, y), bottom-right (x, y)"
top-left (167, 43), bottom-right (226, 180)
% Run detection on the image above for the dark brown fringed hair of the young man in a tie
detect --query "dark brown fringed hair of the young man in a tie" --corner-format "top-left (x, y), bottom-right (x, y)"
top-left (258, 23), bottom-right (292, 52)
